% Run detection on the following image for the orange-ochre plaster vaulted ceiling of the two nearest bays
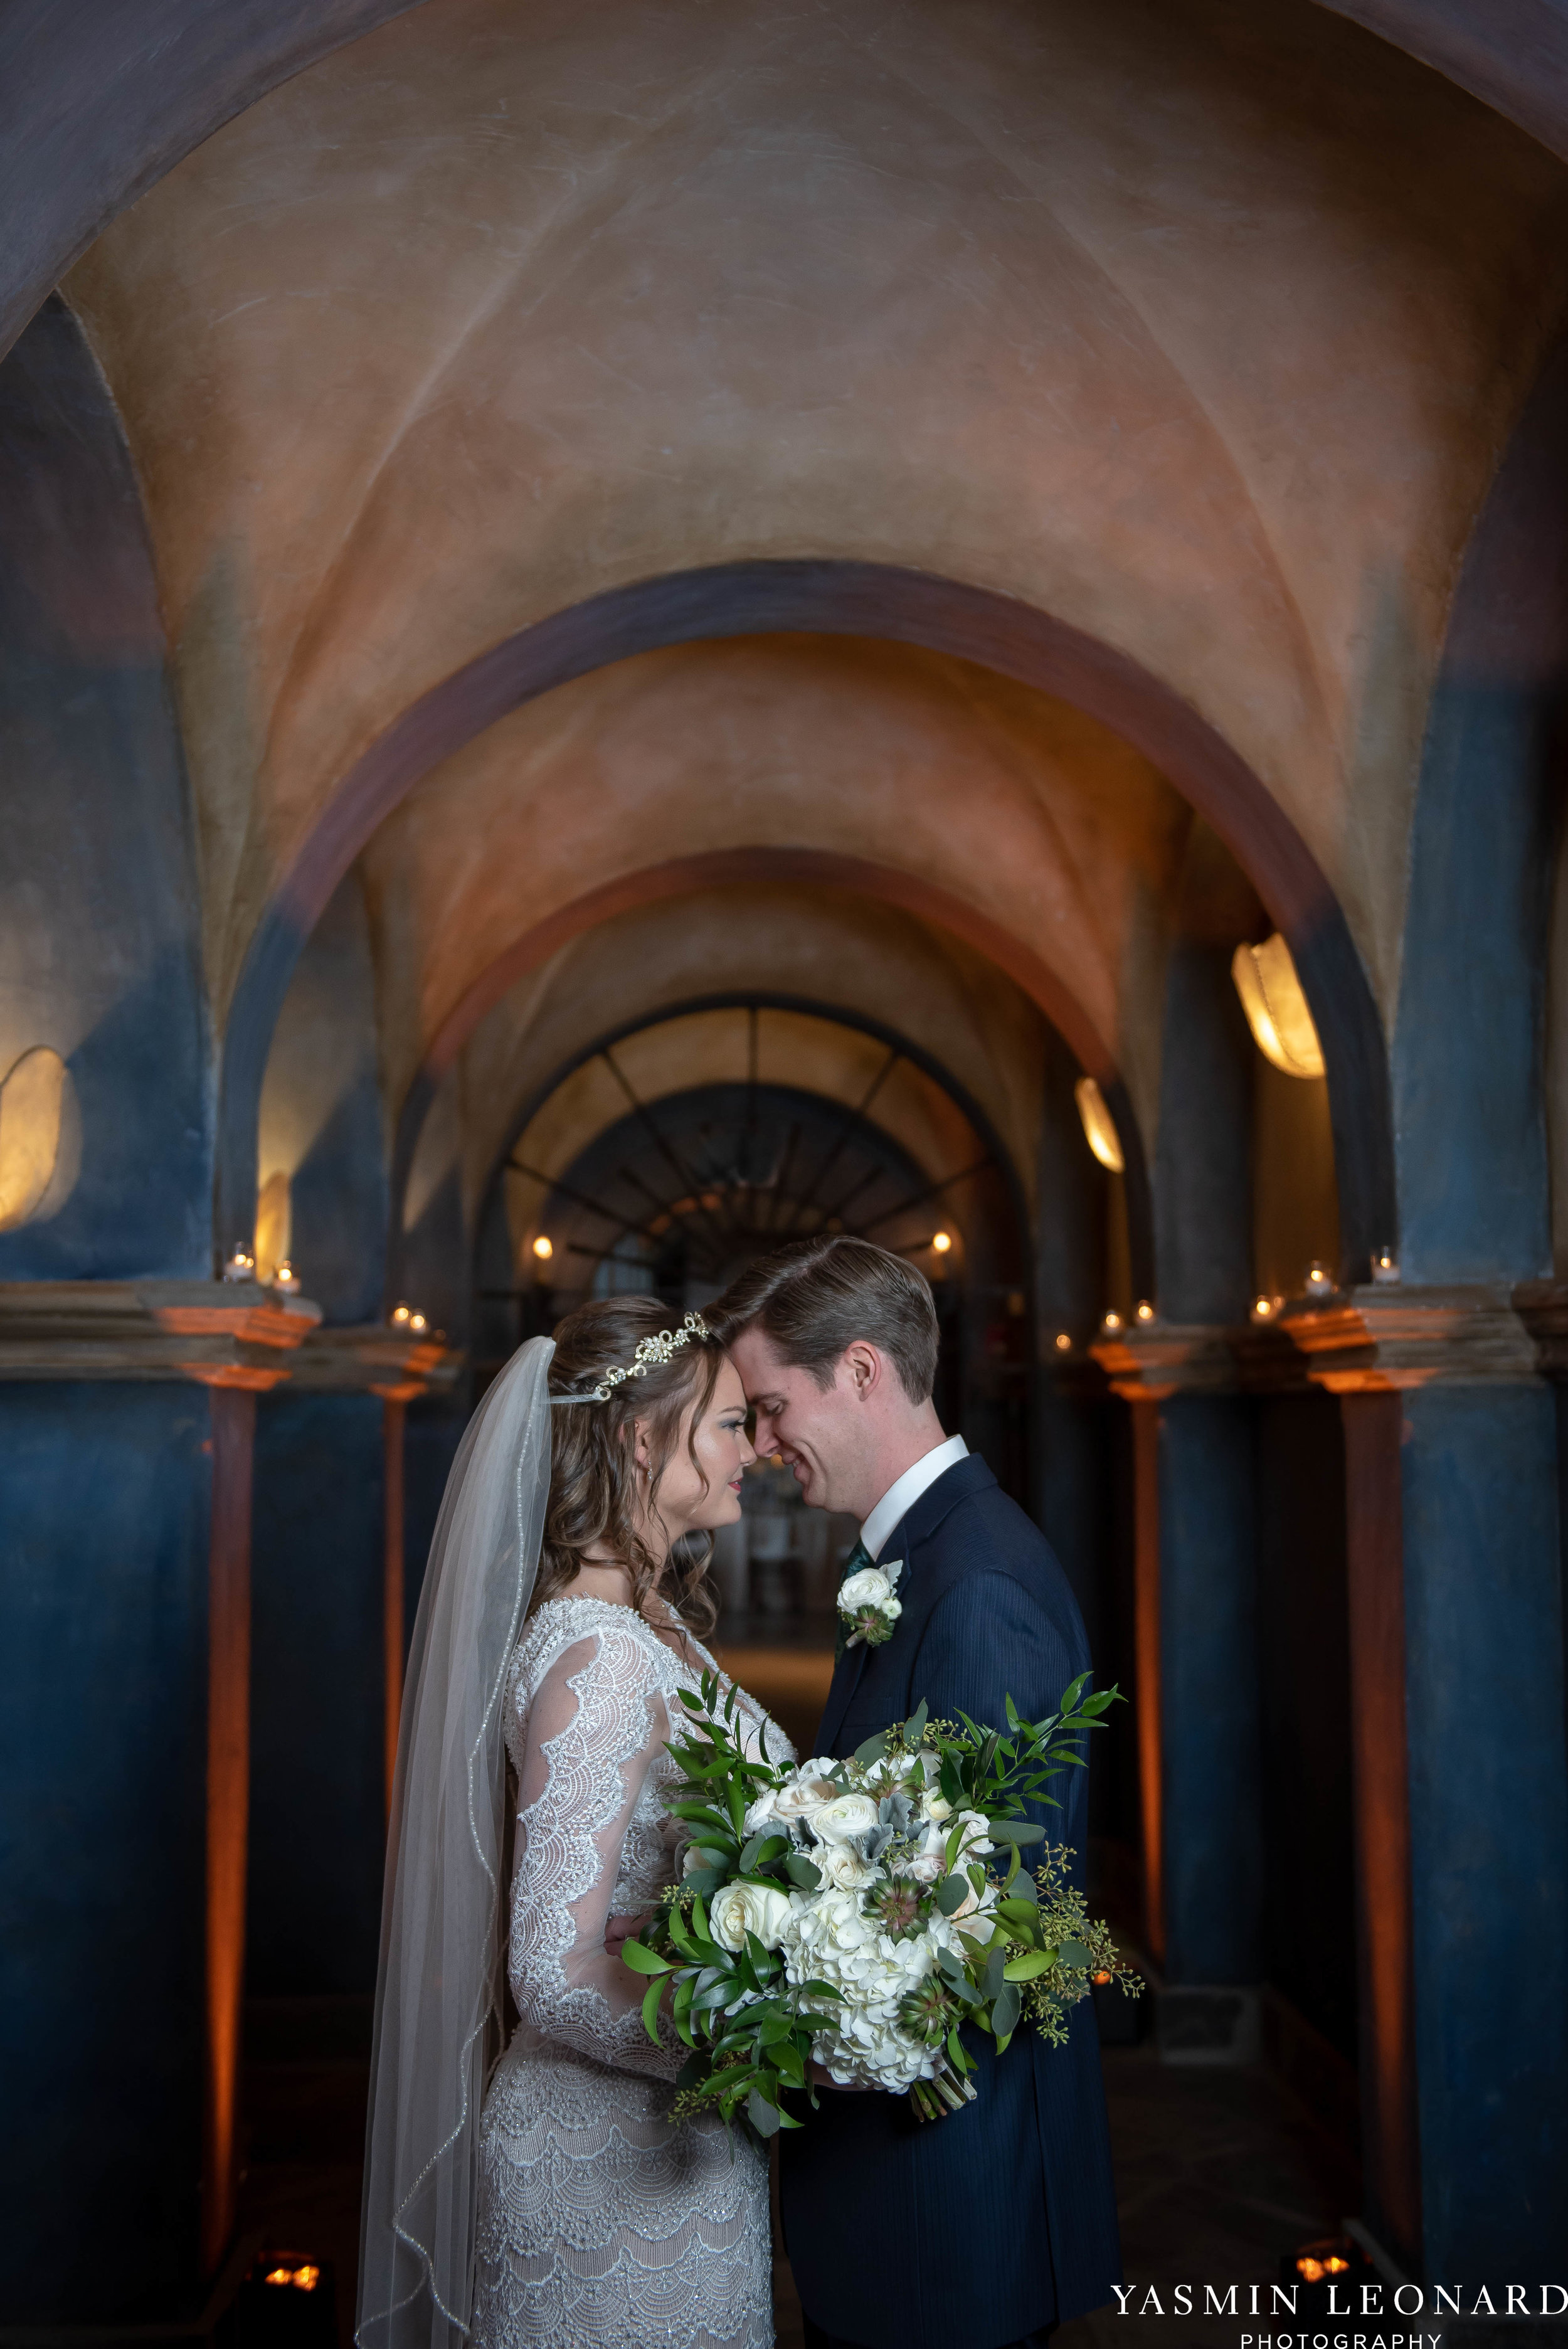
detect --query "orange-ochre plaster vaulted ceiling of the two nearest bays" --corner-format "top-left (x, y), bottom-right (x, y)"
top-left (66, 0), bottom-right (1568, 1066)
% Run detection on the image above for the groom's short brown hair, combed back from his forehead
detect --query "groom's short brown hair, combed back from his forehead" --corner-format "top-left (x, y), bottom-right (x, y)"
top-left (704, 1231), bottom-right (936, 1403)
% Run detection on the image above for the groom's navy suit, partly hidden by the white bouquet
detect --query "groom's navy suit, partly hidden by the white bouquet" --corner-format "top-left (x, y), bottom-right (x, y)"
top-left (780, 1456), bottom-right (1122, 2349)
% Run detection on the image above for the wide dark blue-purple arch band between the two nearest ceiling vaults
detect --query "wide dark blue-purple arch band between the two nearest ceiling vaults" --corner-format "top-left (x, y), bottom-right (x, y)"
top-left (218, 561), bottom-right (1397, 1285)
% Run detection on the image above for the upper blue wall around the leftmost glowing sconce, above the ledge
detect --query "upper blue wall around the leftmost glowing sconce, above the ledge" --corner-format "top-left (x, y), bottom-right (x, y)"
top-left (0, 300), bottom-right (211, 1280)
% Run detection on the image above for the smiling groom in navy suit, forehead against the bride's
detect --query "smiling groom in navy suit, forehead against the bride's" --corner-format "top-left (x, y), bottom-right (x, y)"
top-left (706, 1236), bottom-right (1122, 2349)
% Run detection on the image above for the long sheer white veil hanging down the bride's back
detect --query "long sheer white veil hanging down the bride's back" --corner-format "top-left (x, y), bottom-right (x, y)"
top-left (354, 1337), bottom-right (554, 2349)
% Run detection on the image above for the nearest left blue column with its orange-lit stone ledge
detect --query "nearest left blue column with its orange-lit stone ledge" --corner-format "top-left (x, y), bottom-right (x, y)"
top-left (0, 1280), bottom-right (314, 2326)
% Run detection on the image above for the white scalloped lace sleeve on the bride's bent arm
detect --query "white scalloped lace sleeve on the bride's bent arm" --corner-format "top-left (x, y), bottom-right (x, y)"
top-left (509, 1626), bottom-right (686, 2079)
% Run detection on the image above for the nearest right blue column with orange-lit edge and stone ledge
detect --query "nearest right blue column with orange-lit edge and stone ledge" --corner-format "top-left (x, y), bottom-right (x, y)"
top-left (1291, 1285), bottom-right (1568, 2304)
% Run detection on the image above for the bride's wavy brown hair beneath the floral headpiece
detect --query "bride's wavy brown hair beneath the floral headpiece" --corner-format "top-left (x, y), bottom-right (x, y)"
top-left (528, 1296), bottom-right (723, 1633)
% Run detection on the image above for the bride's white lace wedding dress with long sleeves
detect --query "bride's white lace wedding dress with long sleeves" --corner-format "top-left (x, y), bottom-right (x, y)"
top-left (472, 1598), bottom-right (791, 2349)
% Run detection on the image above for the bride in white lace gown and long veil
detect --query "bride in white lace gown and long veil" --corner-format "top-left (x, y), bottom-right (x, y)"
top-left (357, 1296), bottom-right (788, 2349)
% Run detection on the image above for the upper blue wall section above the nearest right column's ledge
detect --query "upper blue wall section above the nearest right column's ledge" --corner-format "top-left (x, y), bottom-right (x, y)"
top-left (1392, 346), bottom-right (1568, 1280)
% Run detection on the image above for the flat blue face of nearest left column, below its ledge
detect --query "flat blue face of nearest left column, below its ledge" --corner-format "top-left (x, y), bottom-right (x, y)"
top-left (0, 1386), bottom-right (211, 2323)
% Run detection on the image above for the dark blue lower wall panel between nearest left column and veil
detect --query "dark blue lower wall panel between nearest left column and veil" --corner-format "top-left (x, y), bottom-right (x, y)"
top-left (246, 1386), bottom-right (385, 1996)
